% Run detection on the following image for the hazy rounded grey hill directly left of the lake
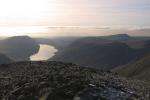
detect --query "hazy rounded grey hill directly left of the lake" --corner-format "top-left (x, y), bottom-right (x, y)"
top-left (0, 36), bottom-right (39, 61)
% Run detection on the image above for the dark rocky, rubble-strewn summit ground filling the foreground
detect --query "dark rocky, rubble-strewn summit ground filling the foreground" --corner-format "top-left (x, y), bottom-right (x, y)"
top-left (0, 62), bottom-right (150, 100)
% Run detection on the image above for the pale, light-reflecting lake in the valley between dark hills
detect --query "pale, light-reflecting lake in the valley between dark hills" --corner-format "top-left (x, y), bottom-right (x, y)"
top-left (30, 44), bottom-right (58, 61)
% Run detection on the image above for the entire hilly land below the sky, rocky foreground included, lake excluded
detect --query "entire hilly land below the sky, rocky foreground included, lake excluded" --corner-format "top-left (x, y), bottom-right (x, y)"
top-left (0, 34), bottom-right (150, 100)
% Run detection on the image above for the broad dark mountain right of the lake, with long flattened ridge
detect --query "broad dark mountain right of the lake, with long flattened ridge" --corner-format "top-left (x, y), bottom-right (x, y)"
top-left (50, 34), bottom-right (150, 70)
